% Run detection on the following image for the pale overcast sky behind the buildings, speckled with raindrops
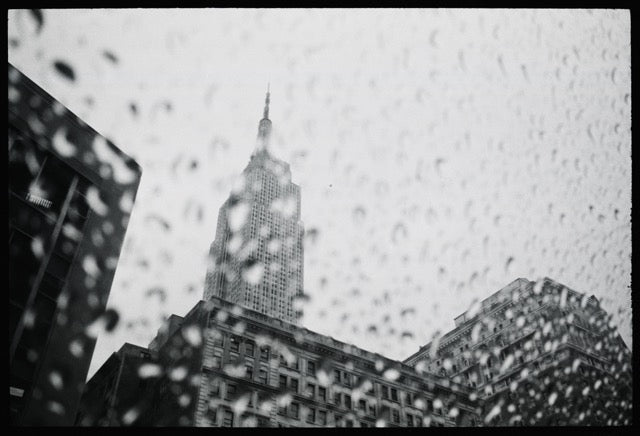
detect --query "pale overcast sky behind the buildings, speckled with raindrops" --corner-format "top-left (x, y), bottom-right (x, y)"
top-left (8, 9), bottom-right (631, 375)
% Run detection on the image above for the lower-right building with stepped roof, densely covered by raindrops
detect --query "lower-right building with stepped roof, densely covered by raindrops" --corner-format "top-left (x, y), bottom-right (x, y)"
top-left (404, 278), bottom-right (632, 425)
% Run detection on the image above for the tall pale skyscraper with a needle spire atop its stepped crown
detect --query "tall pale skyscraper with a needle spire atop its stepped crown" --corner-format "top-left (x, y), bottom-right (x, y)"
top-left (204, 91), bottom-right (304, 323)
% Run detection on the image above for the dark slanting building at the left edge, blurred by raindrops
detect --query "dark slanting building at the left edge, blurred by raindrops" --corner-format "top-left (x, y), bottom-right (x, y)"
top-left (8, 64), bottom-right (141, 425)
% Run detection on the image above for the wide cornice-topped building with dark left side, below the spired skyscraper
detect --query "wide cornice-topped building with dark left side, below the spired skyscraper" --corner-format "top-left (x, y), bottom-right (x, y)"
top-left (78, 297), bottom-right (481, 427)
